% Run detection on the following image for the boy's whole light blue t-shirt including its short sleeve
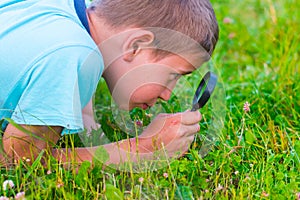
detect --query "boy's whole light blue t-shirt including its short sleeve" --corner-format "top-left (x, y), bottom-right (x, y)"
top-left (0, 0), bottom-right (104, 134)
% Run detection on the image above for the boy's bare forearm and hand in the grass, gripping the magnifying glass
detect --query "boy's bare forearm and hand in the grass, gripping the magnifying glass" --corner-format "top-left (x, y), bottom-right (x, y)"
top-left (53, 111), bottom-right (201, 165)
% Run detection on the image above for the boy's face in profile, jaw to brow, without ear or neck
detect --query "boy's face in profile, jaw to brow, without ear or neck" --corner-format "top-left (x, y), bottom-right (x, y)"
top-left (104, 51), bottom-right (195, 110)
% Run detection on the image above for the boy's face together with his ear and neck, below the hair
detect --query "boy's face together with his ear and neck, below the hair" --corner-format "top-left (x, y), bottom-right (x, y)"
top-left (91, 25), bottom-right (203, 110)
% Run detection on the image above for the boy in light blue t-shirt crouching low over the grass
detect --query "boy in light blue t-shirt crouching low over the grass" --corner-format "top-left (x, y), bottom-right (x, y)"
top-left (0, 0), bottom-right (218, 164)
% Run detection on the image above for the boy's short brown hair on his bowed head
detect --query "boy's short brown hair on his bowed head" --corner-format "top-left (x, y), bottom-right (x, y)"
top-left (90, 0), bottom-right (219, 56)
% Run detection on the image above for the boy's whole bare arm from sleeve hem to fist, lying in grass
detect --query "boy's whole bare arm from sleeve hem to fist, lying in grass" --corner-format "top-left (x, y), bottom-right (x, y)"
top-left (3, 111), bottom-right (201, 165)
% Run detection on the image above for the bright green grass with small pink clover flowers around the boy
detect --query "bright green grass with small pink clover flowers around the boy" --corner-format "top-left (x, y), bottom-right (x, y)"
top-left (0, 0), bottom-right (300, 199)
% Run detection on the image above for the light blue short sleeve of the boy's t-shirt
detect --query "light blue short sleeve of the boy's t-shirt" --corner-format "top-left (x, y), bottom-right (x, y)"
top-left (12, 45), bottom-right (103, 132)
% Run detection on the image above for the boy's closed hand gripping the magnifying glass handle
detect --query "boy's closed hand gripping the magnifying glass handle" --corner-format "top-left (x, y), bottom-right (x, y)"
top-left (136, 111), bottom-right (202, 157)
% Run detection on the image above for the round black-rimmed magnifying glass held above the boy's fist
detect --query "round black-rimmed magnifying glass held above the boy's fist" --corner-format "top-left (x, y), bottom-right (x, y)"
top-left (192, 72), bottom-right (218, 111)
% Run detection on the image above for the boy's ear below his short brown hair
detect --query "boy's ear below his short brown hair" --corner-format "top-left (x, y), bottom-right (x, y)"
top-left (123, 29), bottom-right (154, 62)
